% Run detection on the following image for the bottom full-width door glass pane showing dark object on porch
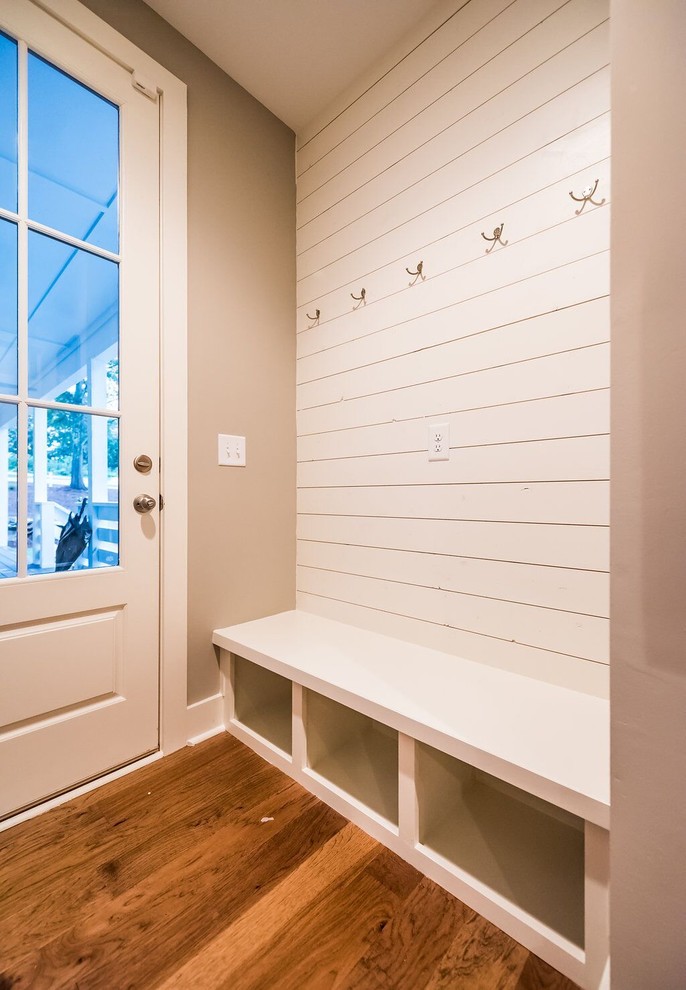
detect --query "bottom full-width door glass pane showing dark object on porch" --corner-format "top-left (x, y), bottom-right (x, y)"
top-left (27, 409), bottom-right (119, 574)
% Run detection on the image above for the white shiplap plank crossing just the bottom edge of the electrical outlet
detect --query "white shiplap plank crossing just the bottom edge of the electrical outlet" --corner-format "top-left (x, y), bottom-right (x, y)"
top-left (298, 431), bottom-right (610, 488)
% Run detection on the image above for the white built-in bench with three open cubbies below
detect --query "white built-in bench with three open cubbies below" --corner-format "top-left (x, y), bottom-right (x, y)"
top-left (213, 611), bottom-right (609, 990)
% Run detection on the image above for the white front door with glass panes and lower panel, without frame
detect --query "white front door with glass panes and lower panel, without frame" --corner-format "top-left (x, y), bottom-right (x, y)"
top-left (0, 0), bottom-right (160, 819)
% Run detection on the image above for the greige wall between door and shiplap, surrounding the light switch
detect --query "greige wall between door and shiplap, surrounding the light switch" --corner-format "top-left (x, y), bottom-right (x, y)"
top-left (85, 0), bottom-right (296, 703)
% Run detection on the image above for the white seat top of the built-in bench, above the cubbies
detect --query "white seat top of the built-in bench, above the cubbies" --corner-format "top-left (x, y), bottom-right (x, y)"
top-left (213, 610), bottom-right (610, 828)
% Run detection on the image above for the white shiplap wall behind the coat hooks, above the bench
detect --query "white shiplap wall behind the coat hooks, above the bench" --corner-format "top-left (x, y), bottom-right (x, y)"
top-left (298, 0), bottom-right (610, 694)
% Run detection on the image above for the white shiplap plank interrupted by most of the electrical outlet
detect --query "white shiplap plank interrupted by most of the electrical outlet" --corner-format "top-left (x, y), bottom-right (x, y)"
top-left (298, 389), bottom-right (610, 461)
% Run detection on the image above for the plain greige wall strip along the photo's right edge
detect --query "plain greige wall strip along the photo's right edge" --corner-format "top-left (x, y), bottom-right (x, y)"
top-left (611, 0), bottom-right (686, 990)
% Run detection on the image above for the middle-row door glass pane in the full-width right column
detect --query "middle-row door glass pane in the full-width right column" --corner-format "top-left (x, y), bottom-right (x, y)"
top-left (29, 231), bottom-right (119, 408)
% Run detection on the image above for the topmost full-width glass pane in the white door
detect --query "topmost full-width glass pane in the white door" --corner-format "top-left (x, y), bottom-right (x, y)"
top-left (29, 54), bottom-right (119, 251)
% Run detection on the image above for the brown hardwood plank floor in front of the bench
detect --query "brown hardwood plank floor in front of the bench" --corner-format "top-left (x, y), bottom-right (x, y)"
top-left (0, 734), bottom-right (574, 990)
